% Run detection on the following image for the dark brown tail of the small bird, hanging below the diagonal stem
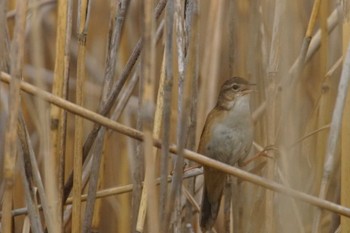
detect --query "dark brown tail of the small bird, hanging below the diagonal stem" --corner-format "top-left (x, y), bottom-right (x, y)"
top-left (200, 176), bottom-right (224, 232)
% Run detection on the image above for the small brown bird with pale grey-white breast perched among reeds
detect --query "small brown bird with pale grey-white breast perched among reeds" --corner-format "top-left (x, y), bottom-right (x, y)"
top-left (198, 77), bottom-right (253, 232)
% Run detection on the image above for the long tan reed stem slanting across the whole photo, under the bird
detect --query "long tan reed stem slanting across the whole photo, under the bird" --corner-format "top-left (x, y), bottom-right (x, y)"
top-left (0, 72), bottom-right (350, 217)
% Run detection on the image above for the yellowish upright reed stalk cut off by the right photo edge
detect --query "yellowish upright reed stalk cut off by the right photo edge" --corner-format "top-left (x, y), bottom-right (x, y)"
top-left (339, 4), bottom-right (350, 232)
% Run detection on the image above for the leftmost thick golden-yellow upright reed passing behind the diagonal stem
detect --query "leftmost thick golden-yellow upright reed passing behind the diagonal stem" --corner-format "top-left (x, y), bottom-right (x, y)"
top-left (49, 1), bottom-right (70, 229)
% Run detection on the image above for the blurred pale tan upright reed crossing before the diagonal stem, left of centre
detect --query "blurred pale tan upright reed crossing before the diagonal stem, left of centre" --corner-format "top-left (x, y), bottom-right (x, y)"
top-left (136, 0), bottom-right (160, 232)
